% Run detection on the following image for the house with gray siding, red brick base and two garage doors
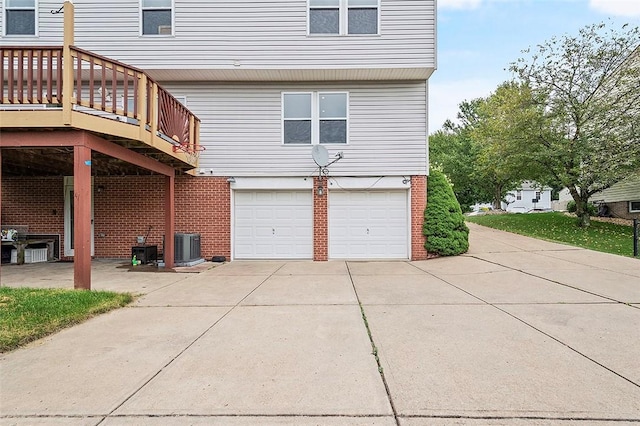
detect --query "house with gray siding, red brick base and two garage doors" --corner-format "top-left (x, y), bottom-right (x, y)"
top-left (0, 0), bottom-right (436, 286)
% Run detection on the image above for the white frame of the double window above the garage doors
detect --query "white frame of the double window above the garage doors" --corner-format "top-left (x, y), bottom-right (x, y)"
top-left (280, 90), bottom-right (350, 146)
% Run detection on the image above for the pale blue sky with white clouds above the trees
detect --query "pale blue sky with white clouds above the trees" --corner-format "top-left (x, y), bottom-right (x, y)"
top-left (429, 0), bottom-right (640, 133)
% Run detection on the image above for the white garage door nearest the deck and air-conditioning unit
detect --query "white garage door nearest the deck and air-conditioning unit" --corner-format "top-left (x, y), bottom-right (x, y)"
top-left (234, 190), bottom-right (313, 259)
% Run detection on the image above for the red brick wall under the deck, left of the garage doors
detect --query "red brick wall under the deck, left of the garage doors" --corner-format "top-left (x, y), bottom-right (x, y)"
top-left (2, 175), bottom-right (231, 258)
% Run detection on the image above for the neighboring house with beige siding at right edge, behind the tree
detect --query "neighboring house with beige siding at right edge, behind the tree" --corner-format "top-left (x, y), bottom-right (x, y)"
top-left (590, 174), bottom-right (640, 219)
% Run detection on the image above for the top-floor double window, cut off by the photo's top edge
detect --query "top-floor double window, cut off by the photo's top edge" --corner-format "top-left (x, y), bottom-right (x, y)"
top-left (309, 0), bottom-right (380, 35)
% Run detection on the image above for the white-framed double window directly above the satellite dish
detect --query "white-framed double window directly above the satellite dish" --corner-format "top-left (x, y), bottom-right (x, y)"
top-left (282, 92), bottom-right (349, 145)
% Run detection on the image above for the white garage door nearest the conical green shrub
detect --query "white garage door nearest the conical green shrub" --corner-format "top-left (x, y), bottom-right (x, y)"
top-left (329, 190), bottom-right (409, 259)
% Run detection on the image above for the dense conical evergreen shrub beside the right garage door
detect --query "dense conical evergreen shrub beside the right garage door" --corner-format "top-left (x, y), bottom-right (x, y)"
top-left (422, 170), bottom-right (469, 256)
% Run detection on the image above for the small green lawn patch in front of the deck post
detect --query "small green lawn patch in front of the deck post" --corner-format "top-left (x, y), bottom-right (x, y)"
top-left (0, 287), bottom-right (133, 353)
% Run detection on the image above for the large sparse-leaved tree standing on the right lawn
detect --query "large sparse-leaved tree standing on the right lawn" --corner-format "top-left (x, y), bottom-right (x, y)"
top-left (510, 24), bottom-right (640, 227)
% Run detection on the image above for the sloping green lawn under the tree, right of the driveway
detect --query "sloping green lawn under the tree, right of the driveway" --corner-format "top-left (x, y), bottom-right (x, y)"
top-left (466, 212), bottom-right (633, 257)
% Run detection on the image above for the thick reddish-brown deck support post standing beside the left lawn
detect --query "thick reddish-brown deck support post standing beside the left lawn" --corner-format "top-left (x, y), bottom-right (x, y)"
top-left (73, 145), bottom-right (91, 290)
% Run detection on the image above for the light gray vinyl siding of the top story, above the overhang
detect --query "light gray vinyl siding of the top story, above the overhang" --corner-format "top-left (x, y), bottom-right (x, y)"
top-left (2, 0), bottom-right (435, 75)
